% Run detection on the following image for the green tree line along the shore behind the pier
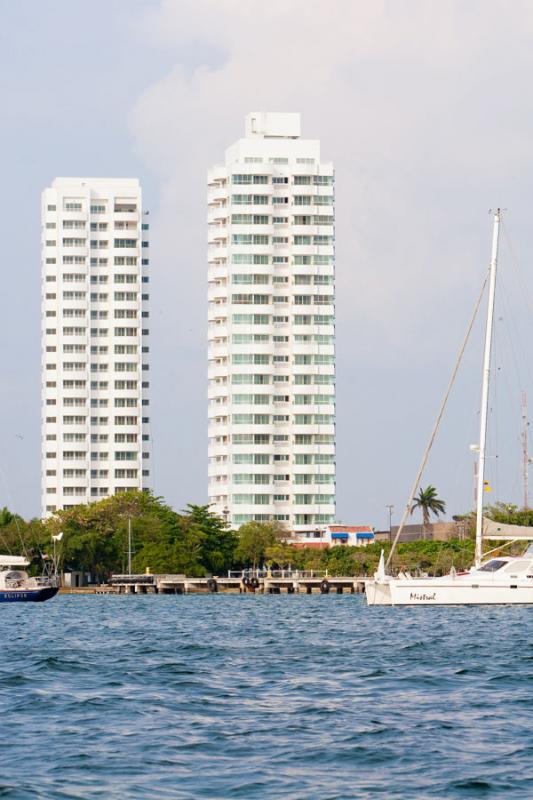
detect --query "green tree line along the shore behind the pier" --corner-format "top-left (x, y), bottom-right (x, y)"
top-left (0, 491), bottom-right (533, 582)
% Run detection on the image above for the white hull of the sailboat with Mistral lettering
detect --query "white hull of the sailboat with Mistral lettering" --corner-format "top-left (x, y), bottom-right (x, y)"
top-left (366, 578), bottom-right (533, 606)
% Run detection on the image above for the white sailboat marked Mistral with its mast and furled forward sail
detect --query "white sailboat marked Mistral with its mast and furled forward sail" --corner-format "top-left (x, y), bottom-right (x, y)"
top-left (366, 209), bottom-right (533, 606)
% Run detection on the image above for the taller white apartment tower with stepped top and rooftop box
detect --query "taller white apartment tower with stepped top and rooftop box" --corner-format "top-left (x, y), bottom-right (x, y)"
top-left (208, 113), bottom-right (335, 532)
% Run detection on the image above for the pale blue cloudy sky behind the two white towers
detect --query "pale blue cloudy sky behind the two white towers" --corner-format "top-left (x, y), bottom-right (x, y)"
top-left (0, 0), bottom-right (533, 528)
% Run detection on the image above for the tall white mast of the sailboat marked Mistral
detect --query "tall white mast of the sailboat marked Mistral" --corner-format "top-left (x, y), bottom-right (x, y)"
top-left (475, 208), bottom-right (501, 567)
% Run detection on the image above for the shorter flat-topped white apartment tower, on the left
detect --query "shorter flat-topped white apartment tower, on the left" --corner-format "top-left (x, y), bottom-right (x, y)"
top-left (42, 178), bottom-right (150, 515)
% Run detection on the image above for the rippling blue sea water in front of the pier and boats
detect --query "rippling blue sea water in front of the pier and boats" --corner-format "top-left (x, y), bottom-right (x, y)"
top-left (0, 595), bottom-right (533, 800)
